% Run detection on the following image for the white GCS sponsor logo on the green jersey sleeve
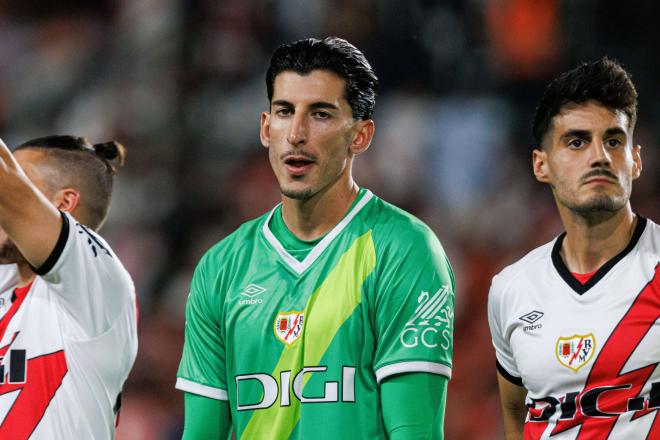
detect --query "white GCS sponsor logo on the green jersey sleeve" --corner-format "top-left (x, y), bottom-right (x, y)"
top-left (399, 286), bottom-right (454, 350)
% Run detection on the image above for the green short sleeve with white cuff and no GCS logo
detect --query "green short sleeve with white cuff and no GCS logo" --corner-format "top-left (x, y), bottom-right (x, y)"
top-left (176, 255), bottom-right (228, 400)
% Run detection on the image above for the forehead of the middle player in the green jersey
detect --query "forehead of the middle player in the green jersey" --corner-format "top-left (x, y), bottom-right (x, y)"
top-left (272, 70), bottom-right (348, 105)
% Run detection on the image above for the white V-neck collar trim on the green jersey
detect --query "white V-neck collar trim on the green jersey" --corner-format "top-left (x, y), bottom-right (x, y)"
top-left (262, 190), bottom-right (373, 275)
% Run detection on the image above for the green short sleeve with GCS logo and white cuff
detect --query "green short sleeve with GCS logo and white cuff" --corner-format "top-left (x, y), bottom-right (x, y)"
top-left (374, 224), bottom-right (454, 383)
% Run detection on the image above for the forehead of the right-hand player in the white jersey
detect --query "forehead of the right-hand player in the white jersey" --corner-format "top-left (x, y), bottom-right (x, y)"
top-left (552, 101), bottom-right (630, 136)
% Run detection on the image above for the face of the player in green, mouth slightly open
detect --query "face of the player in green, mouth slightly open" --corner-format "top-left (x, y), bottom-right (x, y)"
top-left (261, 70), bottom-right (371, 200)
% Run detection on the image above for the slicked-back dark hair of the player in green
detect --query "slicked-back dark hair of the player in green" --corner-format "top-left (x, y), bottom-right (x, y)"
top-left (266, 37), bottom-right (378, 120)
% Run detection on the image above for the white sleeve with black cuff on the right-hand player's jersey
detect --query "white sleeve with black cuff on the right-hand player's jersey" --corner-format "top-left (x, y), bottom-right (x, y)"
top-left (488, 276), bottom-right (522, 385)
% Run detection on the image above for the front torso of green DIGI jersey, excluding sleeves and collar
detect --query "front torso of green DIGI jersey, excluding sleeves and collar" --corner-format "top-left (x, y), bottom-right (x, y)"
top-left (222, 205), bottom-right (384, 438)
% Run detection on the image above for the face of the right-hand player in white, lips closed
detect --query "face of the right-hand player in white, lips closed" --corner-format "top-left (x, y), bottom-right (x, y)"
top-left (534, 101), bottom-right (642, 213)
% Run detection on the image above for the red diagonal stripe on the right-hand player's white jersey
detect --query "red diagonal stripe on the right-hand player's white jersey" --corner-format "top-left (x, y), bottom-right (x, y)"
top-left (552, 264), bottom-right (660, 440)
